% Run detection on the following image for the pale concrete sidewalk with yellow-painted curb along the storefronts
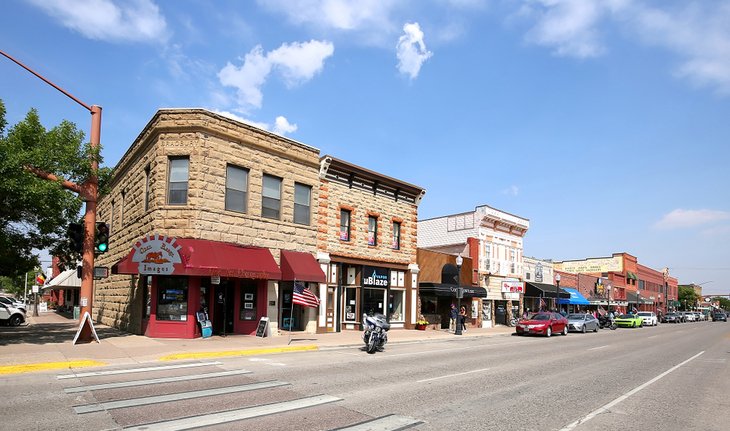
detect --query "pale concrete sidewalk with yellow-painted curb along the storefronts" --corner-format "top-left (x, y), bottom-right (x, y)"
top-left (0, 312), bottom-right (514, 374)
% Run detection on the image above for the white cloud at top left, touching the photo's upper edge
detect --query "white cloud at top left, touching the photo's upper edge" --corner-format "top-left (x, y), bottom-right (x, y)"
top-left (28, 0), bottom-right (167, 42)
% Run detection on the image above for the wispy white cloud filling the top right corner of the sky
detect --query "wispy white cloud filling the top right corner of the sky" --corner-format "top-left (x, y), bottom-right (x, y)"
top-left (633, 1), bottom-right (730, 94)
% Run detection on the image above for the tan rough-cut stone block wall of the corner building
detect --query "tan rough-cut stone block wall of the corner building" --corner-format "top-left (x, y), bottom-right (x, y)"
top-left (93, 109), bottom-right (319, 333)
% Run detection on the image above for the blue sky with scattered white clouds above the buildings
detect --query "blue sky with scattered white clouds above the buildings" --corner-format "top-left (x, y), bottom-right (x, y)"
top-left (0, 0), bottom-right (730, 295)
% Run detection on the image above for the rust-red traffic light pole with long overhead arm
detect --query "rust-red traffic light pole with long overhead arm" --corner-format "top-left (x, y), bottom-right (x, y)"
top-left (0, 50), bottom-right (101, 342)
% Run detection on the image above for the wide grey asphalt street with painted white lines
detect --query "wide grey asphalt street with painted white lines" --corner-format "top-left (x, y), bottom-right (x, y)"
top-left (0, 322), bottom-right (730, 430)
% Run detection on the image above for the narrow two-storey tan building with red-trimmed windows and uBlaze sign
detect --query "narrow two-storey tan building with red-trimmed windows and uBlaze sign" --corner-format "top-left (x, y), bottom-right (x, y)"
top-left (317, 155), bottom-right (425, 332)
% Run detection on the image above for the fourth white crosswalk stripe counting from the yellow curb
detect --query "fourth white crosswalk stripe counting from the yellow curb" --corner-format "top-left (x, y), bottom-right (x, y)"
top-left (124, 395), bottom-right (342, 431)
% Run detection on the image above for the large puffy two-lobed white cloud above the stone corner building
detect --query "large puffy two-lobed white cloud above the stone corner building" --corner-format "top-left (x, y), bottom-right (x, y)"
top-left (218, 40), bottom-right (334, 111)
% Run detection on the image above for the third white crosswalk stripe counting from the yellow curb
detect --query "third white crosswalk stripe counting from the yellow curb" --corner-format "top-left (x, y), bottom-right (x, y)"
top-left (74, 380), bottom-right (289, 414)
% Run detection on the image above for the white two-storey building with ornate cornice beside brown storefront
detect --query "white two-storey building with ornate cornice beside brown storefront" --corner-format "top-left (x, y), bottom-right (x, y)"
top-left (418, 205), bottom-right (530, 327)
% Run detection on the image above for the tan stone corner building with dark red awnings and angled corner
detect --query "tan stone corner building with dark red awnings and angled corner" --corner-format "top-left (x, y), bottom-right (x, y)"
top-left (93, 109), bottom-right (324, 338)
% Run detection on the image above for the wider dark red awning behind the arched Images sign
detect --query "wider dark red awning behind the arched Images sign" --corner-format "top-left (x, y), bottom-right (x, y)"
top-left (112, 238), bottom-right (281, 280)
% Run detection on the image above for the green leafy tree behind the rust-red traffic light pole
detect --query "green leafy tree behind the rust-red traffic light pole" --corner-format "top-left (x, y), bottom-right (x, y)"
top-left (0, 100), bottom-right (111, 276)
